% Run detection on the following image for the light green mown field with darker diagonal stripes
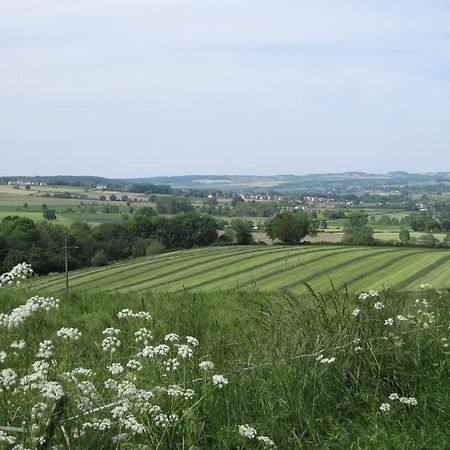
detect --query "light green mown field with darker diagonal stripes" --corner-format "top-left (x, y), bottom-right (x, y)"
top-left (33, 245), bottom-right (450, 294)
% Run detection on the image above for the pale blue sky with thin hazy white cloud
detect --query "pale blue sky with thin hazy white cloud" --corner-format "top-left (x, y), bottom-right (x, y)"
top-left (0, 0), bottom-right (450, 178)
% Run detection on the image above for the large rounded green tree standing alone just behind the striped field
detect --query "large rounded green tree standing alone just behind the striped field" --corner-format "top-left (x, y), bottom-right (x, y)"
top-left (267, 212), bottom-right (317, 245)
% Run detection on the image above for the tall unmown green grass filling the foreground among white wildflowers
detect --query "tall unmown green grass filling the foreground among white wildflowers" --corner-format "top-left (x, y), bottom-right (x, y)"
top-left (0, 288), bottom-right (450, 449)
